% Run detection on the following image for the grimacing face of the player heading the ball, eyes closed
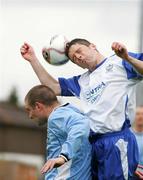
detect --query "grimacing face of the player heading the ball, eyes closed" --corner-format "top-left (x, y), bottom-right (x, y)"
top-left (68, 44), bottom-right (96, 69)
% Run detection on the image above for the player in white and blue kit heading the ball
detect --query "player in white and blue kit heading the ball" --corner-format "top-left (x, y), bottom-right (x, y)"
top-left (21, 39), bottom-right (143, 180)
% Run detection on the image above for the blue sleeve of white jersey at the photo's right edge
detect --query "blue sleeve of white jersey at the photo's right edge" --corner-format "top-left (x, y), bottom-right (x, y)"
top-left (122, 52), bottom-right (143, 79)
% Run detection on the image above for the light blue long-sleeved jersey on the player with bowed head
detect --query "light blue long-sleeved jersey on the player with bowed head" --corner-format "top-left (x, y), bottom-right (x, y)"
top-left (45, 104), bottom-right (91, 180)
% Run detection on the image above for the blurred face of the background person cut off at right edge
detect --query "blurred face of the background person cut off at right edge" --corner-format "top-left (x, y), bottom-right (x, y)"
top-left (135, 107), bottom-right (143, 126)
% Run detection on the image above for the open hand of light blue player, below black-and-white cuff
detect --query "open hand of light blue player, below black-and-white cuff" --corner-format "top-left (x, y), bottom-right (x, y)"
top-left (41, 157), bottom-right (65, 174)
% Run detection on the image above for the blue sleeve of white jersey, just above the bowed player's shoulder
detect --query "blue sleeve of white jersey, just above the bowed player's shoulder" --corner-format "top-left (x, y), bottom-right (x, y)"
top-left (58, 75), bottom-right (80, 97)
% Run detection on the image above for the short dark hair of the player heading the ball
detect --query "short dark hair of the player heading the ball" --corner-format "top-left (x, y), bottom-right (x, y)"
top-left (65, 38), bottom-right (91, 57)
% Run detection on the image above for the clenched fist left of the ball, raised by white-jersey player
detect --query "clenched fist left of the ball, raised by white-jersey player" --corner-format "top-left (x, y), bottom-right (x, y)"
top-left (20, 43), bottom-right (36, 62)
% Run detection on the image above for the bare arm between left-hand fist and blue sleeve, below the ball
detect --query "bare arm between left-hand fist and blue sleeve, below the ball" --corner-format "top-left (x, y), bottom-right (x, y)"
top-left (30, 58), bottom-right (61, 95)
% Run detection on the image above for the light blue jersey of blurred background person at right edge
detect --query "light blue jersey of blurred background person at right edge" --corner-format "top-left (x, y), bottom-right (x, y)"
top-left (132, 130), bottom-right (143, 166)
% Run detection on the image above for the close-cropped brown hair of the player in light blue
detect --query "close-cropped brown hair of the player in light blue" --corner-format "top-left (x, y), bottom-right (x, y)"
top-left (25, 85), bottom-right (57, 107)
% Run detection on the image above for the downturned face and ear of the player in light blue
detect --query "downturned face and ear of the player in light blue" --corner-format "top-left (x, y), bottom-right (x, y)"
top-left (25, 102), bottom-right (47, 126)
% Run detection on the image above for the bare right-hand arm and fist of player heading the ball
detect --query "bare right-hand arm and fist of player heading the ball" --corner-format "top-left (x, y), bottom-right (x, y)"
top-left (112, 42), bottom-right (143, 75)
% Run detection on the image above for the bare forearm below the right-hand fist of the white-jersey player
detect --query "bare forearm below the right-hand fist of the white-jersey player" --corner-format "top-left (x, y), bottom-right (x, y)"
top-left (126, 56), bottom-right (143, 75)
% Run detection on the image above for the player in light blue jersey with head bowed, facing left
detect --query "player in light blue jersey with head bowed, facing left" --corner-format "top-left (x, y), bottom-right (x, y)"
top-left (25, 85), bottom-right (91, 180)
